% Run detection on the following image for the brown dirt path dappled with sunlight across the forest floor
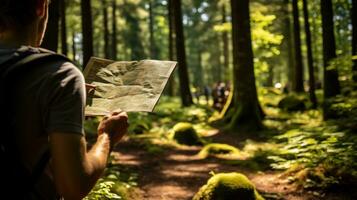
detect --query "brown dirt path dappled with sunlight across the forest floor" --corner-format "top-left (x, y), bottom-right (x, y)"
top-left (115, 135), bottom-right (348, 200)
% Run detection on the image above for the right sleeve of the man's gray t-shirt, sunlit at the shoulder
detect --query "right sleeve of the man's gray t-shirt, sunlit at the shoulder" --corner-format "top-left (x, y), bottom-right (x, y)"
top-left (45, 62), bottom-right (86, 135)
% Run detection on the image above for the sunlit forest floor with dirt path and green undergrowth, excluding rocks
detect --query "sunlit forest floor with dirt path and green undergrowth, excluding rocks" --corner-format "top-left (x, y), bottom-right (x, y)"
top-left (85, 90), bottom-right (357, 200)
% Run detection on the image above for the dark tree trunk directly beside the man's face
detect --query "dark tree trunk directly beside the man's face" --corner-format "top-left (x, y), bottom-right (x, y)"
top-left (41, 0), bottom-right (59, 52)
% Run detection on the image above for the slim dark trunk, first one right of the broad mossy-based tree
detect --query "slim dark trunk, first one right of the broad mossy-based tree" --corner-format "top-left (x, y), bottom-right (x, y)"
top-left (283, 0), bottom-right (295, 89)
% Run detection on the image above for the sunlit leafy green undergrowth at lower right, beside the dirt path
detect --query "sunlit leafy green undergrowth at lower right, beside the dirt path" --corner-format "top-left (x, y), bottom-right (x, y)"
top-left (269, 127), bottom-right (357, 188)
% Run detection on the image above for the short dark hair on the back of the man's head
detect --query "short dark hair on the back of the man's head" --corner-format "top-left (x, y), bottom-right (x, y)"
top-left (0, 0), bottom-right (37, 31)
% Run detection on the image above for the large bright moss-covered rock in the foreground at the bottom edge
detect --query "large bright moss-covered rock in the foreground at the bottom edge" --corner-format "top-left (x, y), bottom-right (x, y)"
top-left (193, 172), bottom-right (264, 200)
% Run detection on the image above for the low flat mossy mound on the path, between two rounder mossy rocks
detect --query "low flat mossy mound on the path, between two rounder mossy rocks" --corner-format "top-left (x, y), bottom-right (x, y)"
top-left (198, 143), bottom-right (239, 158)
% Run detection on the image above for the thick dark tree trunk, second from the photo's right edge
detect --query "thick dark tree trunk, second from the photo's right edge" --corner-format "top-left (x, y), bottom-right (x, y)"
top-left (320, 0), bottom-right (340, 99)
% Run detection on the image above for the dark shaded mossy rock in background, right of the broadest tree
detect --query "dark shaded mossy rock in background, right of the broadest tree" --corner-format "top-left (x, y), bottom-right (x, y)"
top-left (278, 95), bottom-right (306, 111)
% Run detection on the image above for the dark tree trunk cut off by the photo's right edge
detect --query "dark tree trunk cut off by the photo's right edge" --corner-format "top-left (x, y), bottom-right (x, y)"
top-left (351, 0), bottom-right (357, 82)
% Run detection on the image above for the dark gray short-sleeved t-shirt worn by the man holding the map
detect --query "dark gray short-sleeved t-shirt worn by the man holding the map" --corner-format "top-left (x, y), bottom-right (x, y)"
top-left (0, 47), bottom-right (86, 198)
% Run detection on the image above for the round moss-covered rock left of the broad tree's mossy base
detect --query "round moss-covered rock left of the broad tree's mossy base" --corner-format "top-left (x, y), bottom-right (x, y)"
top-left (172, 122), bottom-right (203, 145)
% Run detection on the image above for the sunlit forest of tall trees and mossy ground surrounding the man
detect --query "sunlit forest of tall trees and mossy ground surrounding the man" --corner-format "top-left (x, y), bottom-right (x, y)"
top-left (43, 0), bottom-right (357, 200)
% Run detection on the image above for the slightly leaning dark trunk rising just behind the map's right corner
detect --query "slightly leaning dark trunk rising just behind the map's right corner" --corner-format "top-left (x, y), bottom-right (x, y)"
top-left (171, 0), bottom-right (193, 106)
